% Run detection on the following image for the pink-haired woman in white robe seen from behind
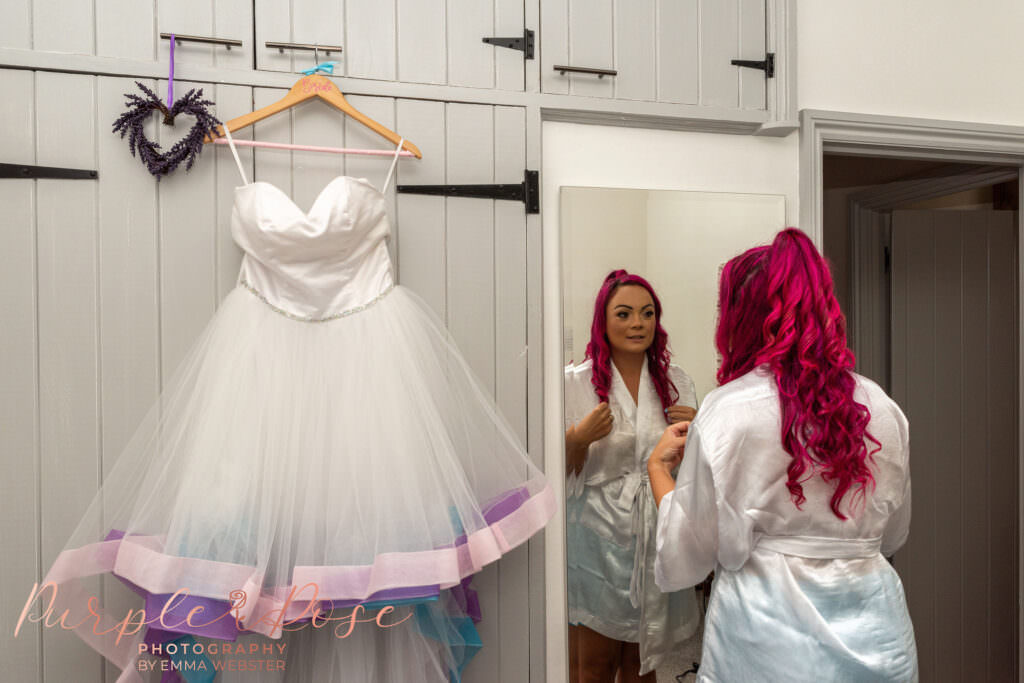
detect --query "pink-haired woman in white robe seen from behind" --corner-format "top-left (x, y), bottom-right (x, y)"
top-left (648, 228), bottom-right (918, 683)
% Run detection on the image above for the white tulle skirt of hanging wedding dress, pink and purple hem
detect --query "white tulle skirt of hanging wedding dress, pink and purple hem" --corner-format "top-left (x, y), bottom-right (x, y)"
top-left (39, 287), bottom-right (555, 681)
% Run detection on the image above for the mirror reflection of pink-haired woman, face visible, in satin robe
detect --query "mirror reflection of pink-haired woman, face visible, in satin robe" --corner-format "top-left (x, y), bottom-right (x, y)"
top-left (565, 270), bottom-right (699, 683)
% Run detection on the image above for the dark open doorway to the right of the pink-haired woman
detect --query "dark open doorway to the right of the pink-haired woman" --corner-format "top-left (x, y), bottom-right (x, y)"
top-left (819, 151), bottom-right (1021, 681)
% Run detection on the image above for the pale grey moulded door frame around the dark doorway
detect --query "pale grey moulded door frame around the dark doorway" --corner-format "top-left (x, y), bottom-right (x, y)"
top-left (800, 110), bottom-right (1024, 661)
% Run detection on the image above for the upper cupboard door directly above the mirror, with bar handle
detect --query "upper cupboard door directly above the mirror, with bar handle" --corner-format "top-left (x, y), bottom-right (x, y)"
top-left (540, 0), bottom-right (767, 111)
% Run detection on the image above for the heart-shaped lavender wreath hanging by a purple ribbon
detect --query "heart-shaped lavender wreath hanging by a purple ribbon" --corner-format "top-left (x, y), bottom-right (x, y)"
top-left (114, 81), bottom-right (220, 181)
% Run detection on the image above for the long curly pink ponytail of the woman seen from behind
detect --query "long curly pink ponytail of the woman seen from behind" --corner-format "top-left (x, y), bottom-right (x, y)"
top-left (715, 227), bottom-right (881, 519)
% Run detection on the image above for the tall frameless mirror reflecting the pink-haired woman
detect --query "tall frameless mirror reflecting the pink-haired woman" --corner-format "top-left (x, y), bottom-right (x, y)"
top-left (560, 187), bottom-right (785, 683)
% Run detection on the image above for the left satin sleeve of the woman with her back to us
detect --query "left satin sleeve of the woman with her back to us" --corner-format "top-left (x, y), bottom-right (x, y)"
top-left (654, 422), bottom-right (718, 592)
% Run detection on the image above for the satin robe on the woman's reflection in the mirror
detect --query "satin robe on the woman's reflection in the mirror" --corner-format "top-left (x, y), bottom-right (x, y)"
top-left (565, 360), bottom-right (699, 673)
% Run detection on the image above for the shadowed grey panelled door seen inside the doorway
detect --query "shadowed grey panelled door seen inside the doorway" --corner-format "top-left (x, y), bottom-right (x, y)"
top-left (892, 211), bottom-right (1019, 681)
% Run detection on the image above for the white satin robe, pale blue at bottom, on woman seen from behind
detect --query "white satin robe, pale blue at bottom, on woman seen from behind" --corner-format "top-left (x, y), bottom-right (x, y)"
top-left (654, 369), bottom-right (918, 683)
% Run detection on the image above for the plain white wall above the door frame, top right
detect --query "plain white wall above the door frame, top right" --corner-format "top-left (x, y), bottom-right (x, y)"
top-left (797, 0), bottom-right (1024, 125)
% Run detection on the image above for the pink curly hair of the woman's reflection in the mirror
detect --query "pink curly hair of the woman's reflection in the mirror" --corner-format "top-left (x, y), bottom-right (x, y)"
top-left (584, 269), bottom-right (679, 422)
